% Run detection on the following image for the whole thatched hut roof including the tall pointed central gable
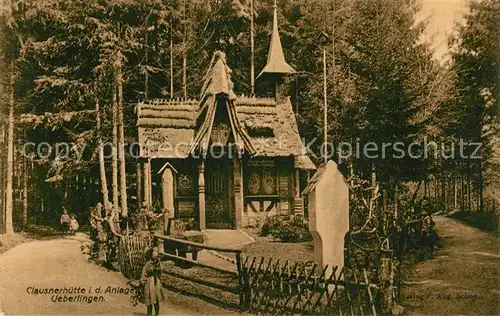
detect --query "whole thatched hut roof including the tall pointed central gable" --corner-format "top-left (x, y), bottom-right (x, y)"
top-left (137, 52), bottom-right (312, 160)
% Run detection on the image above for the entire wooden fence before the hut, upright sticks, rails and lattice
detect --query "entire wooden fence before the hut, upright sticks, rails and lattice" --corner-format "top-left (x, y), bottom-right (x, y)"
top-left (117, 235), bottom-right (383, 316)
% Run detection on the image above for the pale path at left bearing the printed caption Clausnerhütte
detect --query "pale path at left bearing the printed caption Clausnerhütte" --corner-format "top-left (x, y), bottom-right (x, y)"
top-left (0, 236), bottom-right (238, 315)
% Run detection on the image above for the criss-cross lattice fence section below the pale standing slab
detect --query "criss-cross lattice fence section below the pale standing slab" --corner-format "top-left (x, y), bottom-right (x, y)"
top-left (241, 257), bottom-right (378, 315)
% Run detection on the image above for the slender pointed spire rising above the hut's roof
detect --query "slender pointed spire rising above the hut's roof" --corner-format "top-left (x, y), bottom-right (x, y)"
top-left (257, 0), bottom-right (295, 78)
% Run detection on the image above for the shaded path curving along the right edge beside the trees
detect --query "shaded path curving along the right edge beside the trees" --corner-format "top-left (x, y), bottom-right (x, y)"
top-left (402, 216), bottom-right (500, 315)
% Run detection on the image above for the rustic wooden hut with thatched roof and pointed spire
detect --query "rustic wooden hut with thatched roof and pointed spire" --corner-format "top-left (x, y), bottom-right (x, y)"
top-left (137, 3), bottom-right (315, 229)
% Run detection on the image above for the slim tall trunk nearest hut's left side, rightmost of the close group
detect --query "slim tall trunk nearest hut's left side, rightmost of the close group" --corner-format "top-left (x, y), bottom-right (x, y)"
top-left (116, 53), bottom-right (128, 218)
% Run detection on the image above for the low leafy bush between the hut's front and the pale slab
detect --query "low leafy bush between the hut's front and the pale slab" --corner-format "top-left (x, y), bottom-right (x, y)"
top-left (261, 216), bottom-right (312, 242)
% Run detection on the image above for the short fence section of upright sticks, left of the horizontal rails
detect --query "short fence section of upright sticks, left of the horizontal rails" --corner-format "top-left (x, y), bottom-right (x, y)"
top-left (118, 236), bottom-right (152, 280)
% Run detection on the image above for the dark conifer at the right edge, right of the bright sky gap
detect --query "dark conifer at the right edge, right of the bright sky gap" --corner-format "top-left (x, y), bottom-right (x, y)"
top-left (450, 0), bottom-right (500, 210)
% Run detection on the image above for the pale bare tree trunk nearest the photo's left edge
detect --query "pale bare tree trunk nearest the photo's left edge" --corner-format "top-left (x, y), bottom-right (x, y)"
top-left (5, 61), bottom-right (15, 235)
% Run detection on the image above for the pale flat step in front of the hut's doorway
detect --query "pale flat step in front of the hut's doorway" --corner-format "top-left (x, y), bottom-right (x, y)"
top-left (203, 229), bottom-right (255, 248)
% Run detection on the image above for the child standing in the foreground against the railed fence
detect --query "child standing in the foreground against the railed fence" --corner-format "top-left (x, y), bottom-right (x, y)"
top-left (141, 247), bottom-right (167, 315)
